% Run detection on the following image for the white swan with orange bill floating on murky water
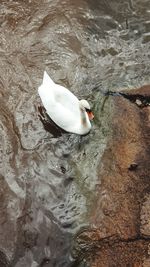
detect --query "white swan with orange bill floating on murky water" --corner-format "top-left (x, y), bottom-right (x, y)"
top-left (38, 71), bottom-right (94, 135)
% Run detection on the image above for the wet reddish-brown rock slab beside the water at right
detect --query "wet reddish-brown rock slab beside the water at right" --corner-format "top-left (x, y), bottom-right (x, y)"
top-left (75, 86), bottom-right (150, 267)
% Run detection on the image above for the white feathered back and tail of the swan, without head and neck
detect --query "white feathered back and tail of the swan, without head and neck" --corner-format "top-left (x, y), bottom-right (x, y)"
top-left (38, 71), bottom-right (80, 131)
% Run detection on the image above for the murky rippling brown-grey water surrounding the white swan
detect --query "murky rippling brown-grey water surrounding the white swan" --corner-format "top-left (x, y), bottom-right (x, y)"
top-left (0, 0), bottom-right (150, 267)
